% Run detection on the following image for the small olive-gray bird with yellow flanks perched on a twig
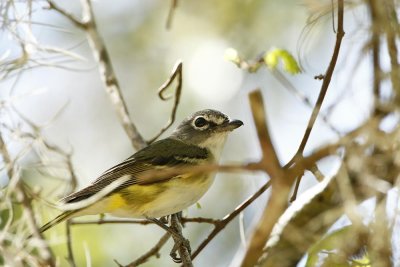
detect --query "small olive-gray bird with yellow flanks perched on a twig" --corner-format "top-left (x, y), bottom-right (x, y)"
top-left (39, 109), bottom-right (243, 232)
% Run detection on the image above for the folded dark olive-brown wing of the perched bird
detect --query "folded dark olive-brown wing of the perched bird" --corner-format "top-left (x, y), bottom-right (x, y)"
top-left (61, 138), bottom-right (210, 203)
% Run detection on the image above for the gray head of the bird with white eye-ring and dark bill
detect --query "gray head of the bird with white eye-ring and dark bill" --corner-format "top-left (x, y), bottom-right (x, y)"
top-left (171, 109), bottom-right (243, 157)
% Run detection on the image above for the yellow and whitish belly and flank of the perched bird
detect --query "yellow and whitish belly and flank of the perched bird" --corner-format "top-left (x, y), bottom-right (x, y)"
top-left (96, 174), bottom-right (214, 218)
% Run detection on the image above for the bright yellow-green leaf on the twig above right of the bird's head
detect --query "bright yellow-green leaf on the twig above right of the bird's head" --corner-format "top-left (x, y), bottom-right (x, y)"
top-left (264, 48), bottom-right (301, 74)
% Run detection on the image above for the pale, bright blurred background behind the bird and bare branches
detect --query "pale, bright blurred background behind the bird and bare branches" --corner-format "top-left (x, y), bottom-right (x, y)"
top-left (0, 0), bottom-right (372, 266)
